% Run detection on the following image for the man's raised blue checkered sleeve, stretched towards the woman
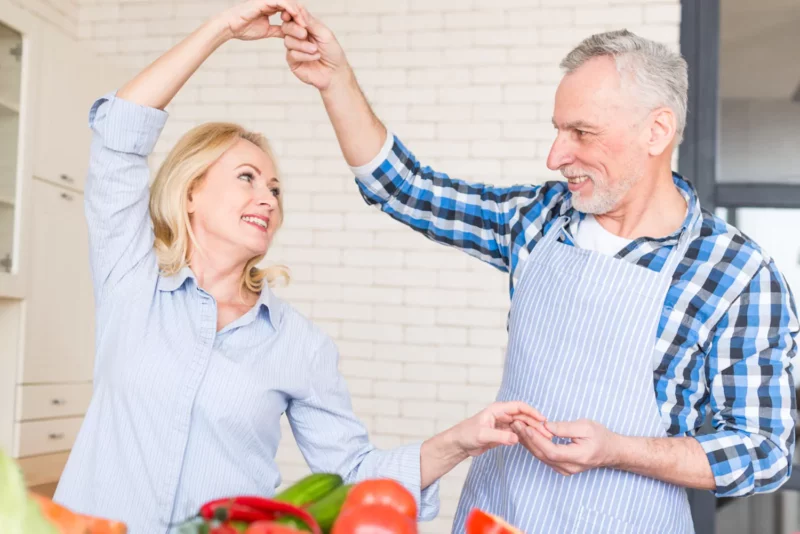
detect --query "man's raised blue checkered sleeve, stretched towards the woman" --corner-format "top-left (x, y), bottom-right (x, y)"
top-left (353, 134), bottom-right (556, 272)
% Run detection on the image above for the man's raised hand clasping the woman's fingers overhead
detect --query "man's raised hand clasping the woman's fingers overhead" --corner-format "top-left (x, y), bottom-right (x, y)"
top-left (281, 7), bottom-right (352, 91)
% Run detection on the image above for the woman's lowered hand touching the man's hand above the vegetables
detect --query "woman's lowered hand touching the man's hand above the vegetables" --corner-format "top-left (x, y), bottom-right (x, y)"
top-left (451, 401), bottom-right (552, 456)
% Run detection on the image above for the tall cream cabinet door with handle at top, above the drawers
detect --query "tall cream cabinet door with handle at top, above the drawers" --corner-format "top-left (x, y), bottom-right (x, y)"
top-left (22, 180), bottom-right (94, 384)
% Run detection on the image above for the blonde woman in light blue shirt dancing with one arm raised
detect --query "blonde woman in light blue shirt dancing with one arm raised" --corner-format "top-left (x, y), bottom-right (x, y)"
top-left (55, 0), bottom-right (541, 534)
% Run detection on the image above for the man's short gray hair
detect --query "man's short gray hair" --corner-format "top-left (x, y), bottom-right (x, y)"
top-left (561, 30), bottom-right (689, 146)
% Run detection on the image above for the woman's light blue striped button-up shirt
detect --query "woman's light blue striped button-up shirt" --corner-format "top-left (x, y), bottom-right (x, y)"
top-left (55, 94), bottom-right (439, 534)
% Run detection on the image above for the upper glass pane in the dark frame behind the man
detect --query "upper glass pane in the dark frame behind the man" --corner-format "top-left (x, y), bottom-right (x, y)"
top-left (717, 0), bottom-right (800, 184)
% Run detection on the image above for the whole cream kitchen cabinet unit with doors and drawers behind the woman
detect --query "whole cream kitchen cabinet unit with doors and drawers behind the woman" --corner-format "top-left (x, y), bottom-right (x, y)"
top-left (0, 0), bottom-right (126, 490)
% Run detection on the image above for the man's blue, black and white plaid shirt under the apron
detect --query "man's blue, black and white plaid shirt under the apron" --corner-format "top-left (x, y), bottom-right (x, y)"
top-left (353, 135), bottom-right (800, 497)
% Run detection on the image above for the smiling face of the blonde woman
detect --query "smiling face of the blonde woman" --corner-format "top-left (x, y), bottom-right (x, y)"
top-left (188, 139), bottom-right (283, 261)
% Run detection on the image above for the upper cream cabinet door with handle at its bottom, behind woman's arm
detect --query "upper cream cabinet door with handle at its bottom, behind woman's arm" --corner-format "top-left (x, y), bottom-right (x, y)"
top-left (33, 30), bottom-right (123, 191)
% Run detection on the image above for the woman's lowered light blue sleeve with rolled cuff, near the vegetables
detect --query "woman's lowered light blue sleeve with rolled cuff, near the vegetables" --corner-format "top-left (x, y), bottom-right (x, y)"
top-left (287, 338), bottom-right (439, 521)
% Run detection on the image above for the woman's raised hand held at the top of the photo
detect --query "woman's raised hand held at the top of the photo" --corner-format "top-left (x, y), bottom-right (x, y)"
top-left (219, 0), bottom-right (306, 41)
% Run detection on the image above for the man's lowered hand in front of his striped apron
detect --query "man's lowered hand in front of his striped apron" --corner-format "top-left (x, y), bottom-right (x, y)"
top-left (511, 419), bottom-right (619, 476)
